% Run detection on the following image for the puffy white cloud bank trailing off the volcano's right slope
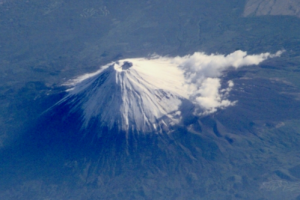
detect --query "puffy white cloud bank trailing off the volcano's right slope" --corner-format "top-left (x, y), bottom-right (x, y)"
top-left (155, 50), bottom-right (284, 115)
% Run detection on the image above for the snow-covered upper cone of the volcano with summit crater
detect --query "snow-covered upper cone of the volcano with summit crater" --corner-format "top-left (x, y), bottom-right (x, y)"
top-left (60, 59), bottom-right (189, 132)
